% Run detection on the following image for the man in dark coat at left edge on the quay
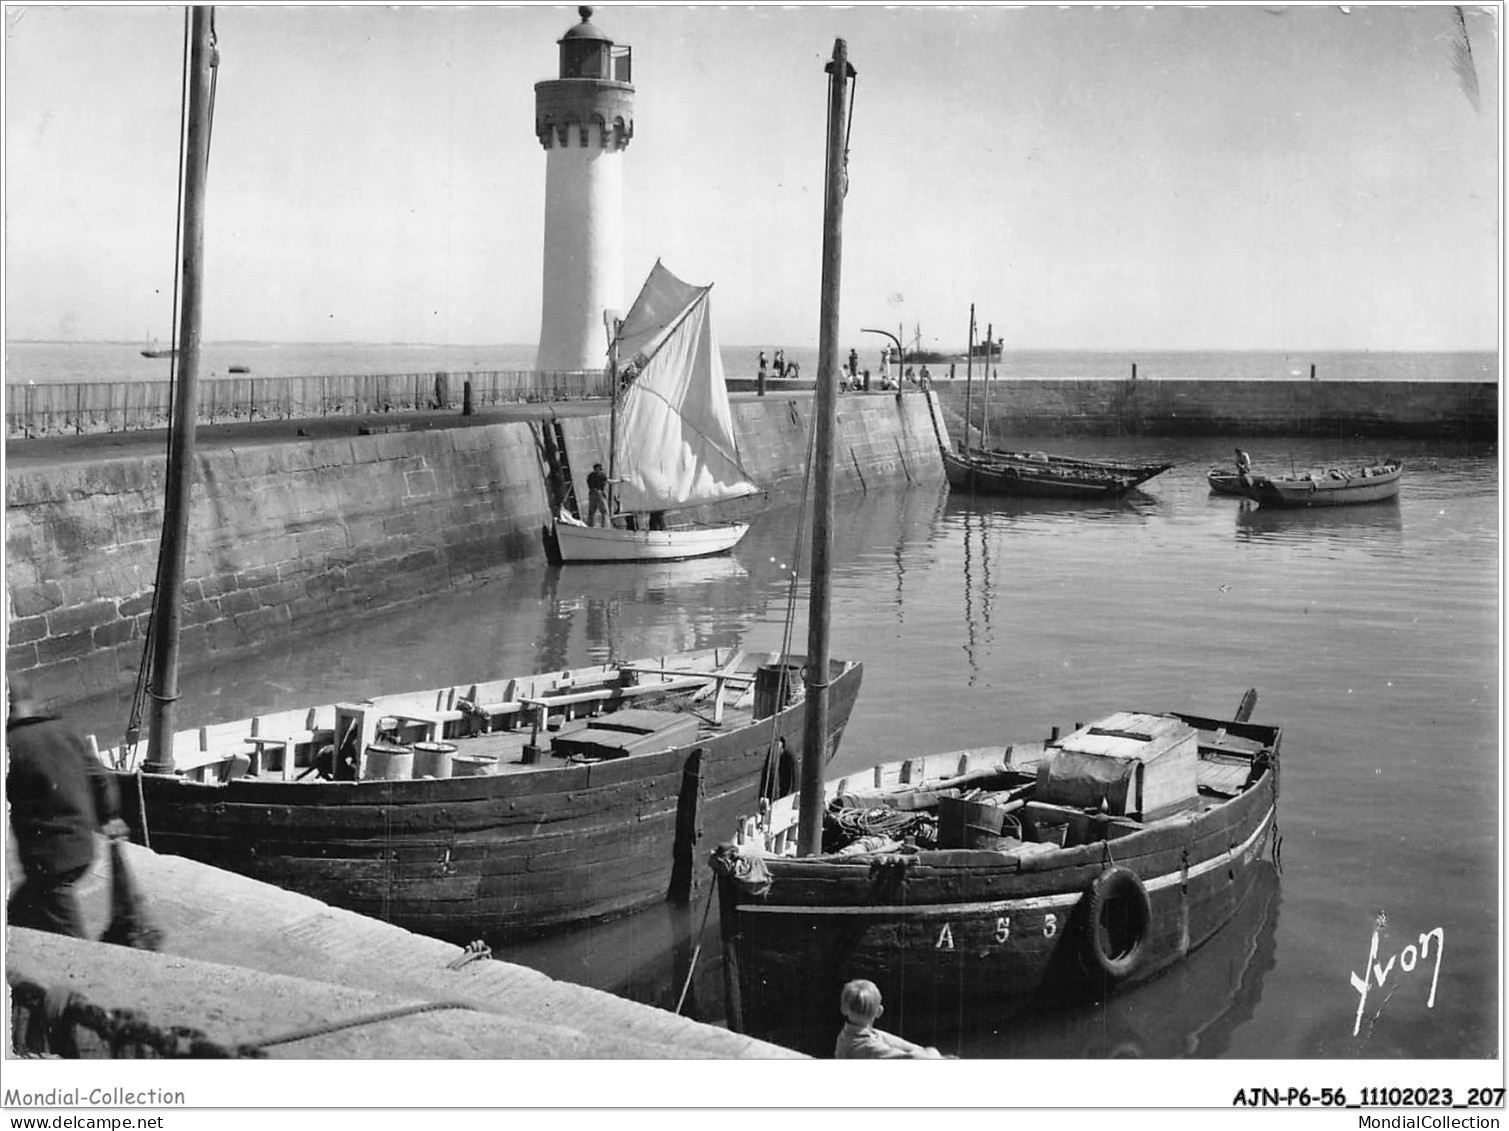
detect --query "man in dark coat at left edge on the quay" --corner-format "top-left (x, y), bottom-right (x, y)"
top-left (5, 680), bottom-right (127, 938)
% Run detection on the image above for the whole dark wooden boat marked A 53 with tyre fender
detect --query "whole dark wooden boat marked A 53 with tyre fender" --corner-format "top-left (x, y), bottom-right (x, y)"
top-left (714, 696), bottom-right (1281, 1054)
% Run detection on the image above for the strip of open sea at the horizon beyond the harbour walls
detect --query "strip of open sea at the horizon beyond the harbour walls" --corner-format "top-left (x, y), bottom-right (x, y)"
top-left (5, 339), bottom-right (1498, 385)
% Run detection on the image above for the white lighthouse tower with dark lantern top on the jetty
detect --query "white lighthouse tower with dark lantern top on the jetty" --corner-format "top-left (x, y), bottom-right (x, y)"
top-left (534, 8), bottom-right (634, 371)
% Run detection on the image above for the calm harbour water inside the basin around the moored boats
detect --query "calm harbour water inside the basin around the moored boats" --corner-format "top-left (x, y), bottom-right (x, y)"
top-left (61, 439), bottom-right (1501, 1059)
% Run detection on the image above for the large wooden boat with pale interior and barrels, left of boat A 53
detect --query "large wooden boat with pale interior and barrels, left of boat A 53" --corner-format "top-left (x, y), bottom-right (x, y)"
top-left (104, 650), bottom-right (862, 943)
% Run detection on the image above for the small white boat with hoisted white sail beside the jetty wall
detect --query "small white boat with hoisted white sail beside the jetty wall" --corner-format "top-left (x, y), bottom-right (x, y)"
top-left (554, 259), bottom-right (758, 562)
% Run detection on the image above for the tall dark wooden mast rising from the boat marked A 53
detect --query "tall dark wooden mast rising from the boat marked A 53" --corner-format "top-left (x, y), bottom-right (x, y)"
top-left (797, 39), bottom-right (857, 857)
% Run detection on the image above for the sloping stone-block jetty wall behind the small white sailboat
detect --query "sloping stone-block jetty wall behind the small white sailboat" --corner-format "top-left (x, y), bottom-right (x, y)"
top-left (5, 395), bottom-right (942, 703)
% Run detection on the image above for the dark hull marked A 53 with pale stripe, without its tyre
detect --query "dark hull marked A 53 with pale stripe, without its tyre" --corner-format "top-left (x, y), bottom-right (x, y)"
top-left (718, 717), bottom-right (1278, 1056)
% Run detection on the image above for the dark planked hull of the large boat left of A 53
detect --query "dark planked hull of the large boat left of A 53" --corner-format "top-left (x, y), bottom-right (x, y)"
top-left (116, 651), bottom-right (862, 944)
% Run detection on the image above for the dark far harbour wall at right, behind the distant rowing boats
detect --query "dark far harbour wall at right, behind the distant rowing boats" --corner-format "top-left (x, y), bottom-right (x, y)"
top-left (933, 379), bottom-right (1498, 440)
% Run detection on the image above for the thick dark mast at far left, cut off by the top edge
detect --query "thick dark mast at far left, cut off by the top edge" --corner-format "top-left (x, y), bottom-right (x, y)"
top-left (143, 8), bottom-right (219, 772)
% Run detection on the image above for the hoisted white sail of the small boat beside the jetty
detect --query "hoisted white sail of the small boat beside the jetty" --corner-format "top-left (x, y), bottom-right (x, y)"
top-left (614, 261), bottom-right (758, 511)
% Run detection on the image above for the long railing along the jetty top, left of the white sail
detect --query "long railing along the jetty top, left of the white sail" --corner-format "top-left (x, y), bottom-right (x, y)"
top-left (5, 369), bottom-right (608, 437)
